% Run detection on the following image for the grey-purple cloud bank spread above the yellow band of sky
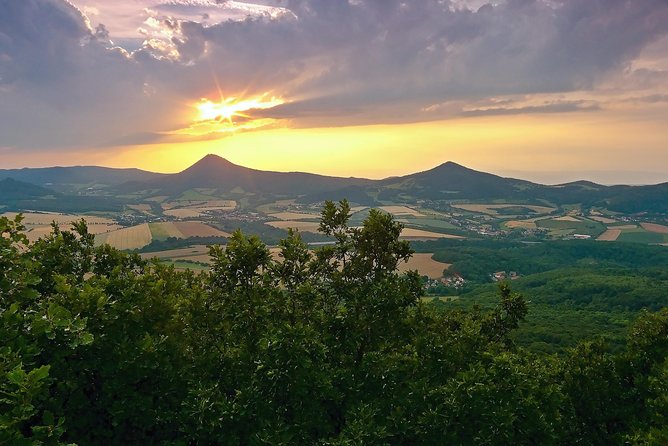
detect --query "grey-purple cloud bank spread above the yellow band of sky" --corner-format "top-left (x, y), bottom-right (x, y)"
top-left (0, 0), bottom-right (668, 148)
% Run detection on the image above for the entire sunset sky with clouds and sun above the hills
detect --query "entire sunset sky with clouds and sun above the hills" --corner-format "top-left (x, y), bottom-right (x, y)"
top-left (0, 0), bottom-right (668, 184)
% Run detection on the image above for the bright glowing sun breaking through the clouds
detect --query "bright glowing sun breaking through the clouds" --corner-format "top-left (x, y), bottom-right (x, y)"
top-left (196, 95), bottom-right (284, 124)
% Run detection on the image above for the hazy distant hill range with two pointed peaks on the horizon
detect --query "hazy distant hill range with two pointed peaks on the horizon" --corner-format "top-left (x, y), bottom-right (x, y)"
top-left (0, 155), bottom-right (668, 214)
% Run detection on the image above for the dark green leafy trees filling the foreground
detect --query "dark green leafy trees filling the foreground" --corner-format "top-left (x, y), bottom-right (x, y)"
top-left (0, 201), bottom-right (668, 445)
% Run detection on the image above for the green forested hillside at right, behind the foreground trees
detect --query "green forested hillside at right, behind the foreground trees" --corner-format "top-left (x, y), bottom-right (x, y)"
top-left (415, 240), bottom-right (668, 352)
